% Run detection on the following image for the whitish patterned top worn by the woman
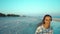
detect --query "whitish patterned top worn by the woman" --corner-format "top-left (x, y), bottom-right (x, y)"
top-left (35, 25), bottom-right (53, 34)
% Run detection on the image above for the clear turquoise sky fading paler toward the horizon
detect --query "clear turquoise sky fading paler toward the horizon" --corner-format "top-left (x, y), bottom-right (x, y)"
top-left (0, 0), bottom-right (60, 16)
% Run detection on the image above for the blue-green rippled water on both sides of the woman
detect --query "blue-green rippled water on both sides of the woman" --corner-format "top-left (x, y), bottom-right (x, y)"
top-left (0, 17), bottom-right (60, 34)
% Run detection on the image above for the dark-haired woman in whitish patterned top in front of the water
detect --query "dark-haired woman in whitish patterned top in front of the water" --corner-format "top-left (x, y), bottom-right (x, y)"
top-left (35, 15), bottom-right (53, 34)
